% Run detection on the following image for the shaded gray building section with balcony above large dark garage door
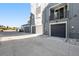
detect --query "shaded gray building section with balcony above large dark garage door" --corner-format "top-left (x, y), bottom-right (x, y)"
top-left (43, 3), bottom-right (79, 38)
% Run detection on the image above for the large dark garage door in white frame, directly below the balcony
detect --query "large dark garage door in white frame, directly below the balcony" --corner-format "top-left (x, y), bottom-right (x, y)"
top-left (51, 23), bottom-right (66, 37)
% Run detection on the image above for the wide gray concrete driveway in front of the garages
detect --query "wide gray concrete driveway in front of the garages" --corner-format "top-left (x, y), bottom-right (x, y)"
top-left (0, 31), bottom-right (79, 56)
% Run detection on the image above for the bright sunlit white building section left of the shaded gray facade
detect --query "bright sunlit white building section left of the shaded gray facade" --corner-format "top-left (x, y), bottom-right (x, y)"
top-left (30, 3), bottom-right (46, 34)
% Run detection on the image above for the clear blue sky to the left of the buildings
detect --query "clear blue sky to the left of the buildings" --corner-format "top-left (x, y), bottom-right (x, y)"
top-left (0, 3), bottom-right (31, 27)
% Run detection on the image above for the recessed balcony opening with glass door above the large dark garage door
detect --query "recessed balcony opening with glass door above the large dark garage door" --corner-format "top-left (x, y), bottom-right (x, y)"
top-left (50, 5), bottom-right (68, 20)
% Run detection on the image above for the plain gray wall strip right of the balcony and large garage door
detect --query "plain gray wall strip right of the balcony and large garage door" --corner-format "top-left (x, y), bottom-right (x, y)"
top-left (70, 3), bottom-right (79, 38)
